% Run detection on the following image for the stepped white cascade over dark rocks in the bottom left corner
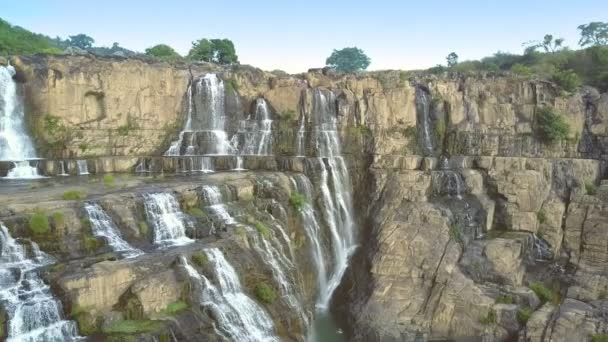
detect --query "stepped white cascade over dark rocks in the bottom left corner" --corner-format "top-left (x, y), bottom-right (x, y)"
top-left (0, 222), bottom-right (81, 342)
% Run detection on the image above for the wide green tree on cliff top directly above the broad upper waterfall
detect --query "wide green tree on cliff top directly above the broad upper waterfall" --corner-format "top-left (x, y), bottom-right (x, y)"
top-left (188, 39), bottom-right (239, 64)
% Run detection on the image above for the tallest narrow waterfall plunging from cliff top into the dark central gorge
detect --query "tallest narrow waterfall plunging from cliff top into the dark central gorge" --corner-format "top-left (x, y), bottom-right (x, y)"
top-left (307, 88), bottom-right (356, 310)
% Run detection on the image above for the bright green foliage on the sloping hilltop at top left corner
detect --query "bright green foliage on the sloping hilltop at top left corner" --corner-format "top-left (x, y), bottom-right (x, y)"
top-left (0, 19), bottom-right (61, 55)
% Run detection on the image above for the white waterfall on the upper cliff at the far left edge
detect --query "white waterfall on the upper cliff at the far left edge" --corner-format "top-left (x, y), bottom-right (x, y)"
top-left (0, 65), bottom-right (40, 178)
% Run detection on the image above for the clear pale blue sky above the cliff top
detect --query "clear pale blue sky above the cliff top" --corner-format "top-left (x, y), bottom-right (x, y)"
top-left (0, 0), bottom-right (608, 72)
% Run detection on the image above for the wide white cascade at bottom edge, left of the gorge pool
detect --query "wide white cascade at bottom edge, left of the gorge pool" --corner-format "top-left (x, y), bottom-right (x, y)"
top-left (182, 248), bottom-right (278, 342)
